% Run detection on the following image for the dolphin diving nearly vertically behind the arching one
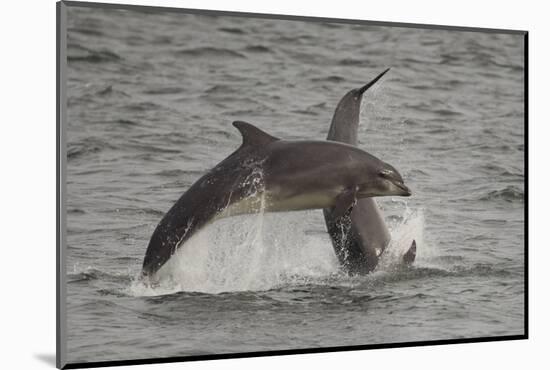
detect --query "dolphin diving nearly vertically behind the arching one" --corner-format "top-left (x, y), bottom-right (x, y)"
top-left (323, 68), bottom-right (416, 274)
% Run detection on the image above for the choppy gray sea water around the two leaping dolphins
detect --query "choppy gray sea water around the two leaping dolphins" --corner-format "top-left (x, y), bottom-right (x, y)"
top-left (67, 7), bottom-right (525, 362)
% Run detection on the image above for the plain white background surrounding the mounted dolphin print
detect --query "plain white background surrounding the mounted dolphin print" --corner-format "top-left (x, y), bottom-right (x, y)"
top-left (0, 0), bottom-right (550, 370)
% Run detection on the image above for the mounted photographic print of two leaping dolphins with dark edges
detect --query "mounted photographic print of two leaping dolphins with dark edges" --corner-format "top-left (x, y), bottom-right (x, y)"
top-left (57, 1), bottom-right (527, 368)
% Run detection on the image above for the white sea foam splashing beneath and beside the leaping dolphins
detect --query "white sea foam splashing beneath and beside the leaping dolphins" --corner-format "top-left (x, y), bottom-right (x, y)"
top-left (130, 204), bottom-right (424, 296)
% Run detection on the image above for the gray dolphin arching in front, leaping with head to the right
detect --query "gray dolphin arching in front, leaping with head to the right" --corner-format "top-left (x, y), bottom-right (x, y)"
top-left (142, 121), bottom-right (410, 276)
